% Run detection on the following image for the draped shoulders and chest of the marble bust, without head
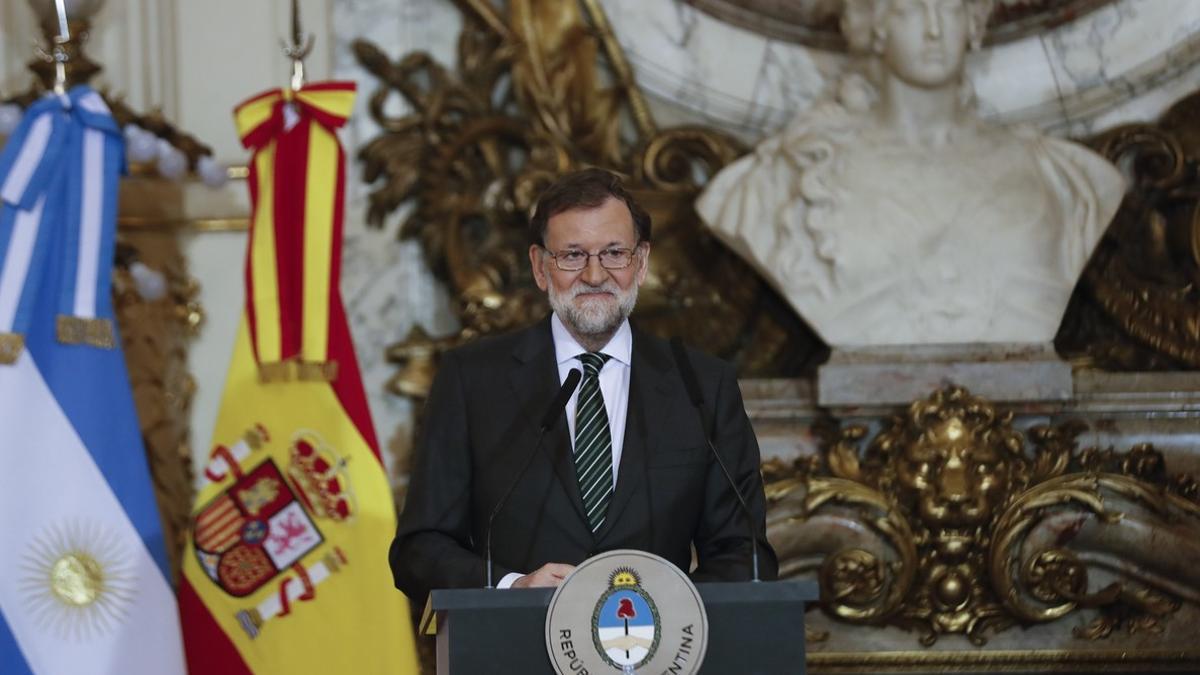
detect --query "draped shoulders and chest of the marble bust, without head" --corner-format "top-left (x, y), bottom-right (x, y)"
top-left (698, 93), bottom-right (1121, 346)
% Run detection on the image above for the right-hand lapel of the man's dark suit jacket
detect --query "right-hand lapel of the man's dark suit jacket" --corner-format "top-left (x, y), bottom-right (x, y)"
top-left (596, 329), bottom-right (671, 542)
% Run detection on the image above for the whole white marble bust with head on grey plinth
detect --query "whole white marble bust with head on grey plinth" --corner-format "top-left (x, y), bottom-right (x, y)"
top-left (696, 0), bottom-right (1124, 350)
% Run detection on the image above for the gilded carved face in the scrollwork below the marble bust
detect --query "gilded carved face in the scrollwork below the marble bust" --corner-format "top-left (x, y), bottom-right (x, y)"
top-left (896, 417), bottom-right (1010, 528)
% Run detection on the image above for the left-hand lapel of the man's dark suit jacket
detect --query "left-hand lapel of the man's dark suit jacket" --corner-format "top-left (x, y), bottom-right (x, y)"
top-left (509, 317), bottom-right (587, 531)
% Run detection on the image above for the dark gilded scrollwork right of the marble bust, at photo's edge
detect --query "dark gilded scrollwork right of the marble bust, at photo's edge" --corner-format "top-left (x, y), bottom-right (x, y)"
top-left (1055, 92), bottom-right (1200, 370)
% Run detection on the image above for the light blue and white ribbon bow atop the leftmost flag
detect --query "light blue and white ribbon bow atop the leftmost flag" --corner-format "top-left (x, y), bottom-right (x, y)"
top-left (0, 85), bottom-right (125, 364)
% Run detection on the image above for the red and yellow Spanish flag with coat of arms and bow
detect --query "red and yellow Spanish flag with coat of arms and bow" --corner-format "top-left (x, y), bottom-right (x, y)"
top-left (179, 82), bottom-right (418, 675)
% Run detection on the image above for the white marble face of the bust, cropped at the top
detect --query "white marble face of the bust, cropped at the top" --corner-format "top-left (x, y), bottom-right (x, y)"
top-left (875, 0), bottom-right (972, 89)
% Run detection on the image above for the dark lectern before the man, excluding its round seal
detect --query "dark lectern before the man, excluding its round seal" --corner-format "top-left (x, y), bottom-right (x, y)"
top-left (425, 581), bottom-right (818, 675)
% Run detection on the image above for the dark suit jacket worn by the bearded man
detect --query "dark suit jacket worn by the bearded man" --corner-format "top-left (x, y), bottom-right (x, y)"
top-left (389, 318), bottom-right (778, 603)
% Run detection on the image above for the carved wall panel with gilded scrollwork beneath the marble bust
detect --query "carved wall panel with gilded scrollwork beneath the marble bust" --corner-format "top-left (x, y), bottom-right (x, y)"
top-left (742, 372), bottom-right (1200, 673)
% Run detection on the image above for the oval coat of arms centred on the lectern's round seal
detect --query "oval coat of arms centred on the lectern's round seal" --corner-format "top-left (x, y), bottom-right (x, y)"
top-left (592, 567), bottom-right (662, 673)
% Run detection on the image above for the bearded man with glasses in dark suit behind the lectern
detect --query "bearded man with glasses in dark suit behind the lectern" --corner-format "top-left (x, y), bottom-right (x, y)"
top-left (389, 169), bottom-right (778, 602)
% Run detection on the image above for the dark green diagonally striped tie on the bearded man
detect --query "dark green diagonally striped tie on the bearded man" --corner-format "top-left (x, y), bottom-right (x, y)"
top-left (575, 352), bottom-right (612, 532)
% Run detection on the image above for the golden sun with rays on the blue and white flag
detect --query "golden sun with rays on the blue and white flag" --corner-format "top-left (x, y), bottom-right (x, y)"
top-left (20, 520), bottom-right (137, 641)
